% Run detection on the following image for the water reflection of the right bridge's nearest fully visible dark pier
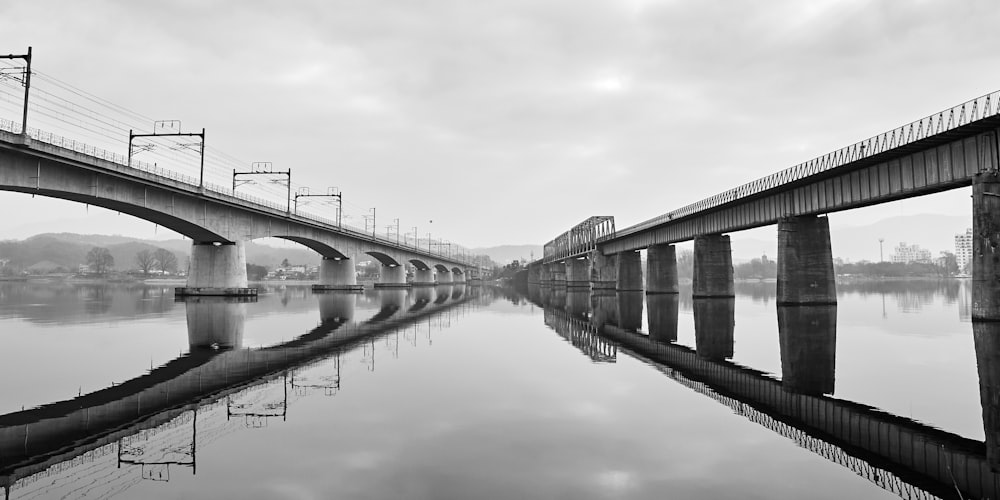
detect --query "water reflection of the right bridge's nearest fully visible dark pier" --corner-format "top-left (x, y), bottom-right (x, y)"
top-left (778, 305), bottom-right (837, 396)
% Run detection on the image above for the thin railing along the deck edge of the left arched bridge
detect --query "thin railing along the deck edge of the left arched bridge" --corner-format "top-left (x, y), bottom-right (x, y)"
top-left (0, 118), bottom-right (474, 266)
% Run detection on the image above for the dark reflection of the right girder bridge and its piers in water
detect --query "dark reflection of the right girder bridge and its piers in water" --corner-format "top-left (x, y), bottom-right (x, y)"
top-left (528, 286), bottom-right (1000, 498)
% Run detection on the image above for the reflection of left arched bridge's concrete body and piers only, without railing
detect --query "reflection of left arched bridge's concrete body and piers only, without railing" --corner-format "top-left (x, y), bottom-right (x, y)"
top-left (0, 285), bottom-right (480, 492)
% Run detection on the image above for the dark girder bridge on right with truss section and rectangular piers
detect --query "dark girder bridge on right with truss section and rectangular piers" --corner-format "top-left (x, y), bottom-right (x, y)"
top-left (528, 92), bottom-right (1000, 320)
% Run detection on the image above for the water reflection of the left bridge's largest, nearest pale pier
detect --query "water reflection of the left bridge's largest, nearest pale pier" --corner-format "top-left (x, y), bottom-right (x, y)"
top-left (184, 297), bottom-right (252, 350)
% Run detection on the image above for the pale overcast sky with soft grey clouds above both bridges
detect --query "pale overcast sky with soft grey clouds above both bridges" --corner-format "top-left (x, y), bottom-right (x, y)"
top-left (0, 0), bottom-right (1000, 247)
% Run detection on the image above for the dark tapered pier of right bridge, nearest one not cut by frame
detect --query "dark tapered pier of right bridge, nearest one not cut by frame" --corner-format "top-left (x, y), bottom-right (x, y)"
top-left (777, 215), bottom-right (837, 305)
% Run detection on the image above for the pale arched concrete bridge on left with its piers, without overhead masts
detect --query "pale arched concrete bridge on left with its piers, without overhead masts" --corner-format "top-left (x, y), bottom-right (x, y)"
top-left (0, 122), bottom-right (479, 295)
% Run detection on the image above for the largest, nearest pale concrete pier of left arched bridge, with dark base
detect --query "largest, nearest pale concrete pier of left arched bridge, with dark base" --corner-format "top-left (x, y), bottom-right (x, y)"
top-left (180, 241), bottom-right (257, 297)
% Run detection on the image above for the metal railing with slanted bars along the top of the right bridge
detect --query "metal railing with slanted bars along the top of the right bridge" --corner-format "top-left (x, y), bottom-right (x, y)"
top-left (618, 91), bottom-right (1000, 236)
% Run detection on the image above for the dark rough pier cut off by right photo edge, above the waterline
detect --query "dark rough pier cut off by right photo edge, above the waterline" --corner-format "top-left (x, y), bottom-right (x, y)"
top-left (972, 174), bottom-right (1000, 321)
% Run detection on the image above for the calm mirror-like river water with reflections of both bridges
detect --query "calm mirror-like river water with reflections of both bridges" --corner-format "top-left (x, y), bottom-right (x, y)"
top-left (0, 281), bottom-right (1000, 500)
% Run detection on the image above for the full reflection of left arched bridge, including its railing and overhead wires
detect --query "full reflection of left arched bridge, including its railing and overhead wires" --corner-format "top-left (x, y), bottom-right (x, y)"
top-left (0, 285), bottom-right (487, 499)
